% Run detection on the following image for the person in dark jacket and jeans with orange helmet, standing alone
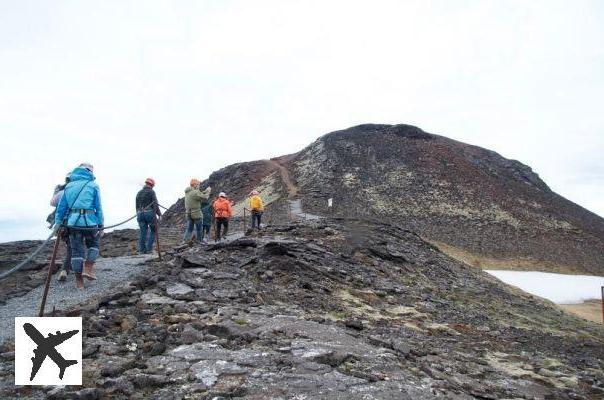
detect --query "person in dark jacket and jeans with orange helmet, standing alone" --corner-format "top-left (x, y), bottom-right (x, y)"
top-left (136, 178), bottom-right (161, 254)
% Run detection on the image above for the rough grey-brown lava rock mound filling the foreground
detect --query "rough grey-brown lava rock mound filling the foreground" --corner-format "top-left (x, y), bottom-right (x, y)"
top-left (0, 219), bottom-right (604, 400)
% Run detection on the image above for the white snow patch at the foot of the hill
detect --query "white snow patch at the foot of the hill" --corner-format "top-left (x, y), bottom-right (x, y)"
top-left (485, 270), bottom-right (604, 304)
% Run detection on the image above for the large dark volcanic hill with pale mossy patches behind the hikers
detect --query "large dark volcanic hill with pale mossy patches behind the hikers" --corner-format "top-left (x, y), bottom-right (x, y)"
top-left (167, 124), bottom-right (604, 275)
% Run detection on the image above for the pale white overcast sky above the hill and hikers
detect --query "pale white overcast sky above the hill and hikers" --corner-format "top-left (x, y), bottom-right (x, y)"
top-left (0, 0), bottom-right (604, 241)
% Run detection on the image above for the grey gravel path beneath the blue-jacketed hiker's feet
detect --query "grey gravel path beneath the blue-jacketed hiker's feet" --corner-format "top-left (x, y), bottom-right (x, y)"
top-left (0, 255), bottom-right (155, 343)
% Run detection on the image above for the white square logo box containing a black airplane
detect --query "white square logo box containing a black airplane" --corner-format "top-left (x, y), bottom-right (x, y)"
top-left (15, 317), bottom-right (82, 385)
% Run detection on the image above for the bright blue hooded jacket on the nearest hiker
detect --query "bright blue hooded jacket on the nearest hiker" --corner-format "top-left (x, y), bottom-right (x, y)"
top-left (55, 167), bottom-right (103, 227)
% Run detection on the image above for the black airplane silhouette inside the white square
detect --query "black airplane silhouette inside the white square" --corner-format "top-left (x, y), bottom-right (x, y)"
top-left (23, 323), bottom-right (79, 381)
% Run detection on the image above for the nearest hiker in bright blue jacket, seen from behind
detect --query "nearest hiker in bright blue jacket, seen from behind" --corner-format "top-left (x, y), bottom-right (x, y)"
top-left (55, 163), bottom-right (104, 289)
